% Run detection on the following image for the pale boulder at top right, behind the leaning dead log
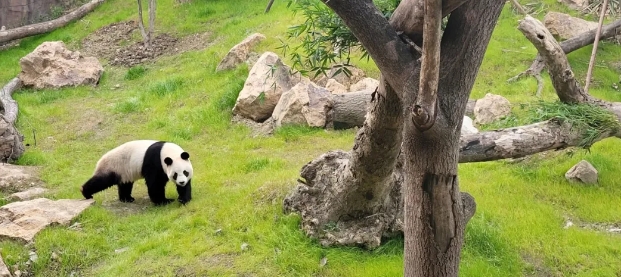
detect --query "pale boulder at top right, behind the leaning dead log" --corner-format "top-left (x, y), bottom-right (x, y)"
top-left (543, 12), bottom-right (597, 40)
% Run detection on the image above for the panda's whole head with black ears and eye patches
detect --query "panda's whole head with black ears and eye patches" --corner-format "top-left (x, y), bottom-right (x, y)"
top-left (162, 143), bottom-right (194, 187)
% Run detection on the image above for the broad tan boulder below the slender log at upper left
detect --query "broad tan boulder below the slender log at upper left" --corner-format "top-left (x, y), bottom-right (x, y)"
top-left (19, 41), bottom-right (104, 89)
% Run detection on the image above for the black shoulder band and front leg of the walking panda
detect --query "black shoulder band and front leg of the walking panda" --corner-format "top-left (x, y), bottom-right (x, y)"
top-left (141, 141), bottom-right (175, 206)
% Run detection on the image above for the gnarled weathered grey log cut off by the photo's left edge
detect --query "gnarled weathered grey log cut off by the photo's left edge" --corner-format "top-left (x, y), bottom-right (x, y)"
top-left (0, 78), bottom-right (25, 162)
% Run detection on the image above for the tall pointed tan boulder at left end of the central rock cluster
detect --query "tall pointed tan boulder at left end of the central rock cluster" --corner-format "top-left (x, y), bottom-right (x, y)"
top-left (233, 52), bottom-right (303, 122)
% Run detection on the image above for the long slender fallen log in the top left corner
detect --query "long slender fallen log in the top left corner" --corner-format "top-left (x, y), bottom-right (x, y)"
top-left (0, 0), bottom-right (105, 43)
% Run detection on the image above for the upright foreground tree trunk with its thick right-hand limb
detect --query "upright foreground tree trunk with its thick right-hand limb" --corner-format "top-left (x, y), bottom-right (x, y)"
top-left (403, 0), bottom-right (504, 276)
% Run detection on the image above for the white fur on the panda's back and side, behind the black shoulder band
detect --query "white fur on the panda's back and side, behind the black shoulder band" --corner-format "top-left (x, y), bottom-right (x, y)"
top-left (95, 140), bottom-right (157, 183)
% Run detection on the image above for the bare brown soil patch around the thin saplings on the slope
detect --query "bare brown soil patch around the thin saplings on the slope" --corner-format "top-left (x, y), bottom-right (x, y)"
top-left (82, 21), bottom-right (211, 67)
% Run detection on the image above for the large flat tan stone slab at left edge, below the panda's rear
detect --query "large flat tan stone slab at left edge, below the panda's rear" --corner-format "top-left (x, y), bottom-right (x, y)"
top-left (0, 198), bottom-right (95, 243)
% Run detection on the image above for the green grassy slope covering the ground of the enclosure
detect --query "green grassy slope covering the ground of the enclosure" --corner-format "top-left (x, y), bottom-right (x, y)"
top-left (0, 0), bottom-right (621, 276)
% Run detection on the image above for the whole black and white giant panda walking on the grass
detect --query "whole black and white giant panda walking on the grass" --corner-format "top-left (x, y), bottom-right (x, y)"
top-left (80, 140), bottom-right (193, 206)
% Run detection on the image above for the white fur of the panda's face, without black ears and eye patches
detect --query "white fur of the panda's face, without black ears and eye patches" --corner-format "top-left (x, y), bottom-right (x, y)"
top-left (160, 142), bottom-right (194, 187)
